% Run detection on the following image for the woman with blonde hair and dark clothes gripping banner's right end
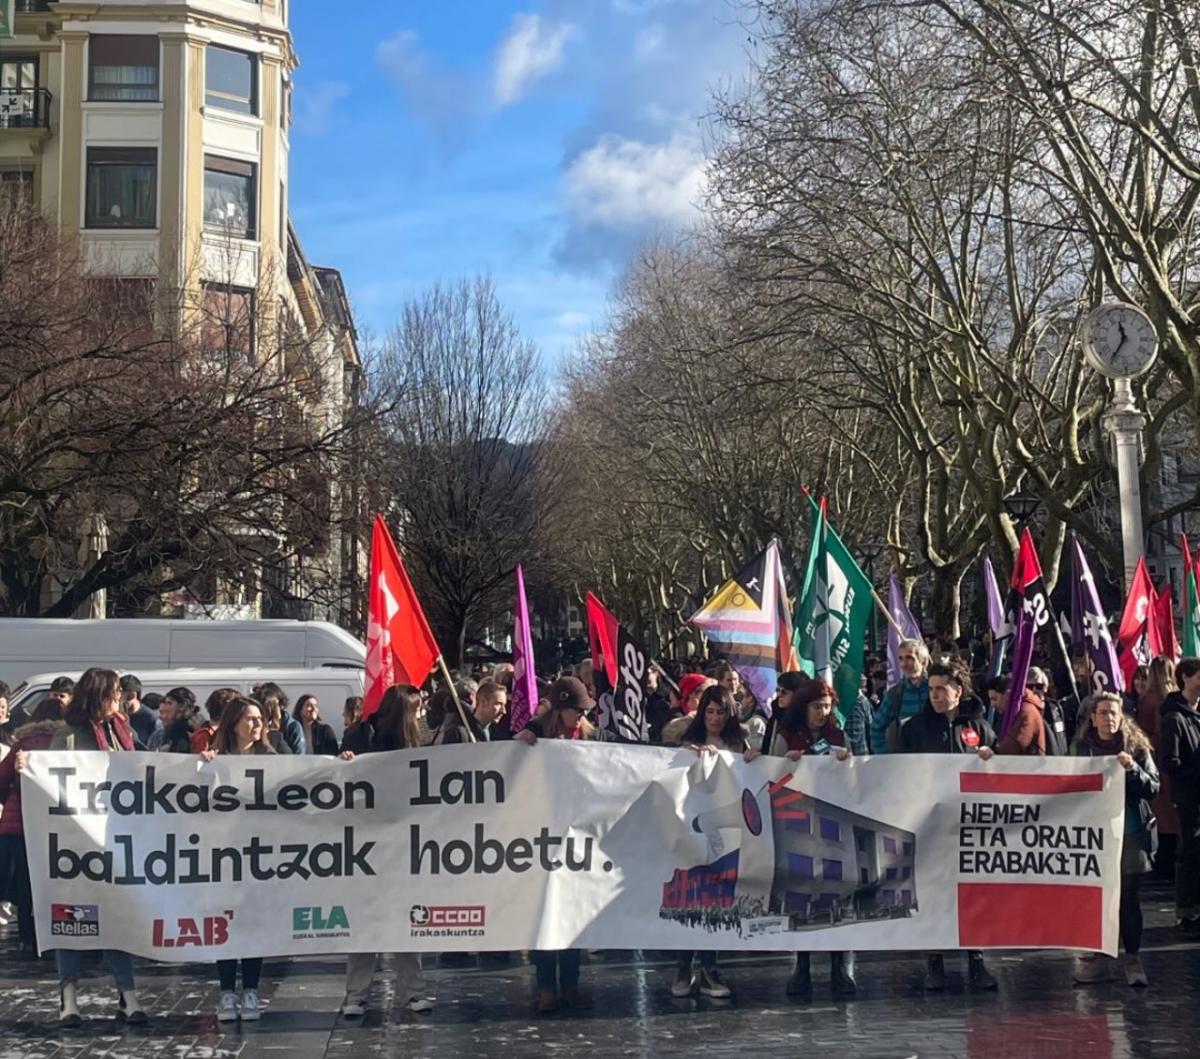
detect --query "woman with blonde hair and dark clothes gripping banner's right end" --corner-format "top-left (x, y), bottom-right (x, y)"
top-left (1070, 692), bottom-right (1159, 986)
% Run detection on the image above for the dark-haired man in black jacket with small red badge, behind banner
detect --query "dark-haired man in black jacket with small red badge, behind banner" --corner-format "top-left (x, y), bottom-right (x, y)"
top-left (900, 662), bottom-right (997, 992)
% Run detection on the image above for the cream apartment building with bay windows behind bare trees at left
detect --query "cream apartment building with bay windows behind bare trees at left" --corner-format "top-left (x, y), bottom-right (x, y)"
top-left (0, 0), bottom-right (359, 617)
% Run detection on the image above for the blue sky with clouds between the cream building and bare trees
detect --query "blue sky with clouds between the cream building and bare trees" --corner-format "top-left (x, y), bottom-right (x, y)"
top-left (290, 0), bottom-right (746, 361)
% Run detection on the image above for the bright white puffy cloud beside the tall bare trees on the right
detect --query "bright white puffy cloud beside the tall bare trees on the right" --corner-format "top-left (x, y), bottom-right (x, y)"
top-left (566, 134), bottom-right (706, 228)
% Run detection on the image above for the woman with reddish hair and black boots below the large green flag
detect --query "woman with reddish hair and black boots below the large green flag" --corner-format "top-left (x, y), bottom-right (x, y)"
top-left (745, 674), bottom-right (858, 998)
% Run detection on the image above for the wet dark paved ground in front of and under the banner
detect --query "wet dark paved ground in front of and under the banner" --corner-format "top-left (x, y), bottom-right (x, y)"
top-left (0, 887), bottom-right (1200, 1059)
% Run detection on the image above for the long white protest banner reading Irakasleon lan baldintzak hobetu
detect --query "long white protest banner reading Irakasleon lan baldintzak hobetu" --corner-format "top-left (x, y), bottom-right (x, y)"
top-left (22, 741), bottom-right (1124, 961)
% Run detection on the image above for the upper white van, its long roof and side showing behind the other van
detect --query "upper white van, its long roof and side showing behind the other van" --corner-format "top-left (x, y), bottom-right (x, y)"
top-left (0, 618), bottom-right (366, 684)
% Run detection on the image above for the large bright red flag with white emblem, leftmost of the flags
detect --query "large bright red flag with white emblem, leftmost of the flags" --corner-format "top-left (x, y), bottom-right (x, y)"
top-left (362, 515), bottom-right (442, 717)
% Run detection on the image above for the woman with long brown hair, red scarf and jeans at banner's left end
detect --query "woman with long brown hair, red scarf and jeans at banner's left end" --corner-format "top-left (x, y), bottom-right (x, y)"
top-left (50, 668), bottom-right (146, 1025)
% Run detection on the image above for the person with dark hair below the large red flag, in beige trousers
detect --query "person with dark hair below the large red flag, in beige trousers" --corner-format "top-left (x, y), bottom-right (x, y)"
top-left (341, 684), bottom-right (433, 1018)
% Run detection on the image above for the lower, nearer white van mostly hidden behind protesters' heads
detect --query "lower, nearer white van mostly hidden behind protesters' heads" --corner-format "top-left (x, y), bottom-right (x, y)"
top-left (10, 666), bottom-right (362, 740)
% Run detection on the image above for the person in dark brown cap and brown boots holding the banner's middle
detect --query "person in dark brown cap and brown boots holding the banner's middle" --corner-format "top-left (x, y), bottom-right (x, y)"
top-left (514, 676), bottom-right (614, 1015)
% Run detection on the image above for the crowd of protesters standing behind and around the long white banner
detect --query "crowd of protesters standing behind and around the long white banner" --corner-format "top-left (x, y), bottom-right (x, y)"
top-left (0, 640), bottom-right (1200, 1024)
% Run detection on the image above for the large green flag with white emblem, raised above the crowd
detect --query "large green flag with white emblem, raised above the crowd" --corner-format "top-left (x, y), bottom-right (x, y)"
top-left (792, 497), bottom-right (872, 724)
